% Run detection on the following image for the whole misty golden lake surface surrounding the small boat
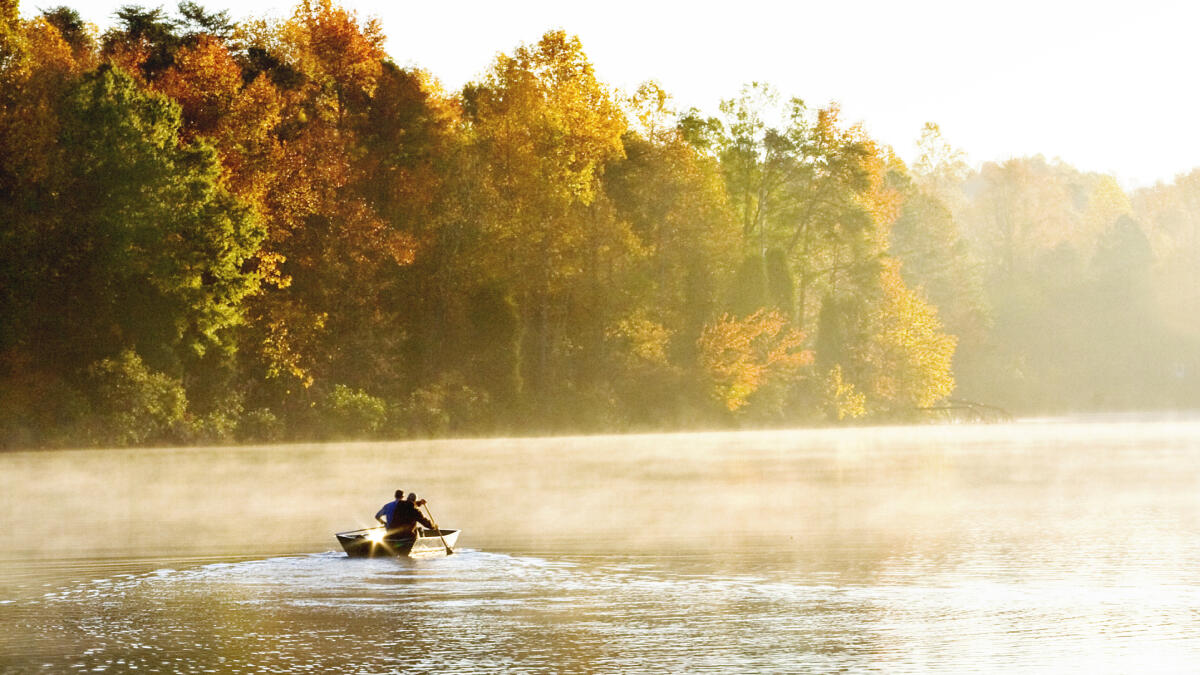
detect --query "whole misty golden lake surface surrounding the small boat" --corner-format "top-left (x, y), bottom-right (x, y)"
top-left (0, 418), bottom-right (1200, 673)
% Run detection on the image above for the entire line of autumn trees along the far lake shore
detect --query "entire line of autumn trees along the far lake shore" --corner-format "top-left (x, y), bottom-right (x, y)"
top-left (0, 0), bottom-right (1200, 447)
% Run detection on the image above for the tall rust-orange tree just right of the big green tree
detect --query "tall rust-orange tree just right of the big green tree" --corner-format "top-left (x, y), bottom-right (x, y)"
top-left (222, 1), bottom-right (429, 425)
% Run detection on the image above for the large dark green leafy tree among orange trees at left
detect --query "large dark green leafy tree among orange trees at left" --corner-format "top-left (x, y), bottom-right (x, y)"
top-left (52, 67), bottom-right (263, 370)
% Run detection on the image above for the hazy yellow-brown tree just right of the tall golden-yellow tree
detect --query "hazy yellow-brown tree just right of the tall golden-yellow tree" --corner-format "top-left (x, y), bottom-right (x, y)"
top-left (604, 83), bottom-right (739, 425)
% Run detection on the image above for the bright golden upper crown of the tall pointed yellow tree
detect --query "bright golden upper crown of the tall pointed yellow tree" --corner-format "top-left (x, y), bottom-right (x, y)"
top-left (464, 31), bottom-right (625, 270)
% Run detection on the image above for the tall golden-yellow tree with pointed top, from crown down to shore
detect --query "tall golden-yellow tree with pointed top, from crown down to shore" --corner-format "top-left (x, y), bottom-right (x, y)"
top-left (463, 31), bottom-right (636, 420)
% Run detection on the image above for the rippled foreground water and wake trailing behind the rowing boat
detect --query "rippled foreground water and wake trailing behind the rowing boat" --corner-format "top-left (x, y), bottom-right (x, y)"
top-left (4, 550), bottom-right (1200, 673)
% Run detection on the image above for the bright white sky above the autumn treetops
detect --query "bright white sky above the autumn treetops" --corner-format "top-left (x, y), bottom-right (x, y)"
top-left (32, 0), bottom-right (1200, 186)
